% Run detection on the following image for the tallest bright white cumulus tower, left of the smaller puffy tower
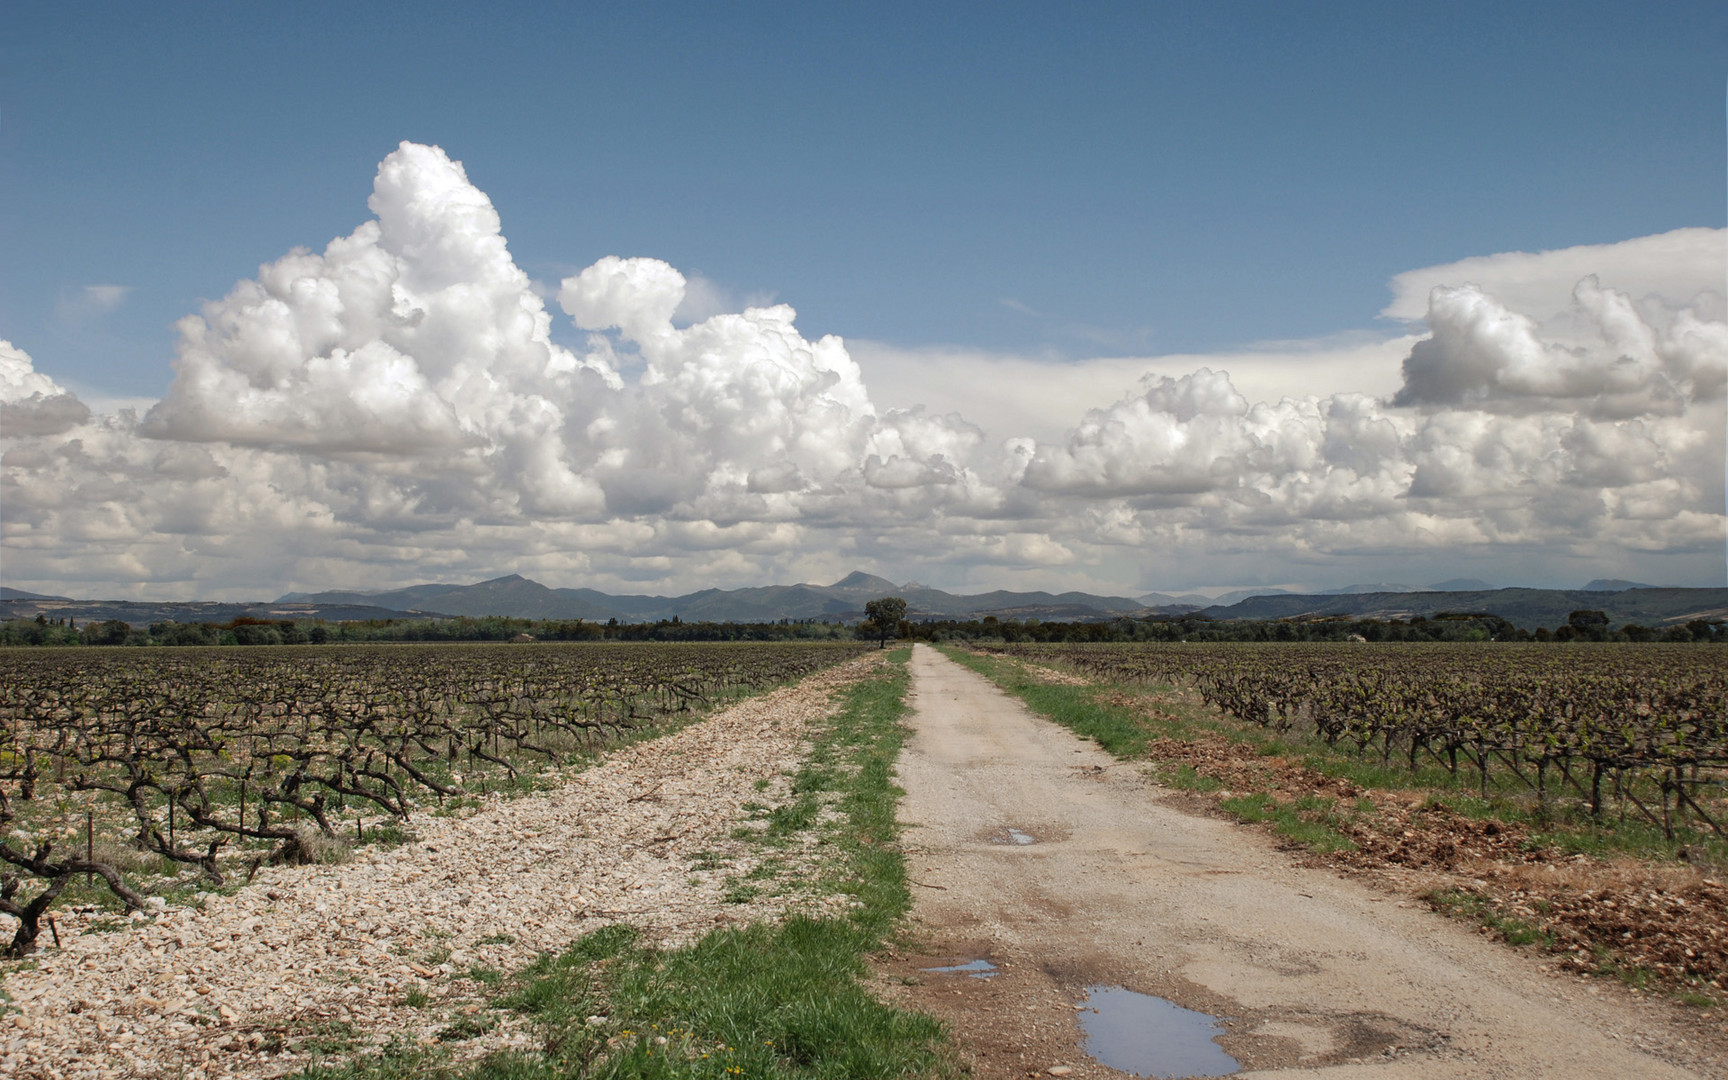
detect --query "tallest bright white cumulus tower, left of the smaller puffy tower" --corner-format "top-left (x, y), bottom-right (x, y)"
top-left (143, 143), bottom-right (617, 517)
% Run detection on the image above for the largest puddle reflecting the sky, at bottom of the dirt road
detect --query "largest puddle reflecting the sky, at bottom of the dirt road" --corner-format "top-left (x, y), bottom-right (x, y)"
top-left (1078, 987), bottom-right (1242, 1078)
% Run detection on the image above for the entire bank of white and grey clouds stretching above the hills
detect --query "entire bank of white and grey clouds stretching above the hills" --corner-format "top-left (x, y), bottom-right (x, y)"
top-left (0, 143), bottom-right (1728, 596)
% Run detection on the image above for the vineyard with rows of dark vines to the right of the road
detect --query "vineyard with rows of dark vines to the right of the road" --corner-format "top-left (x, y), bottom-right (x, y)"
top-left (990, 643), bottom-right (1728, 838)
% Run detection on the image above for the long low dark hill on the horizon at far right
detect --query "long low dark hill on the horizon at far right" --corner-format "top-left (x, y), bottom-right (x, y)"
top-left (1201, 589), bottom-right (1728, 629)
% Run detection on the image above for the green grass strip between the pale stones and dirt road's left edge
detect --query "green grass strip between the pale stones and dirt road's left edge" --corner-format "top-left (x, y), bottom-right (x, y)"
top-left (306, 650), bottom-right (943, 1080)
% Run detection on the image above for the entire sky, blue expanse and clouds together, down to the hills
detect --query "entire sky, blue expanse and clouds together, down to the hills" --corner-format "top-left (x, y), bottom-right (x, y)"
top-left (0, 3), bottom-right (1728, 596)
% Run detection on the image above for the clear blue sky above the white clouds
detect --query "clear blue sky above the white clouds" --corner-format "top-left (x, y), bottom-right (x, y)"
top-left (0, 3), bottom-right (1728, 396)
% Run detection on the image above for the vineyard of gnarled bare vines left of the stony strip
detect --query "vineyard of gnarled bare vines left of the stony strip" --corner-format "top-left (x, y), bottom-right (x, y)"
top-left (0, 645), bottom-right (862, 954)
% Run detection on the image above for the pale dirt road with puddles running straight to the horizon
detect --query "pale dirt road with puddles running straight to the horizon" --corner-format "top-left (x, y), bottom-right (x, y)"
top-left (892, 646), bottom-right (1728, 1080)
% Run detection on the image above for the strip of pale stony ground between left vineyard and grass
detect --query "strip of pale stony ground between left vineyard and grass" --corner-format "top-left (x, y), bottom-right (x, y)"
top-left (0, 658), bottom-right (878, 1078)
